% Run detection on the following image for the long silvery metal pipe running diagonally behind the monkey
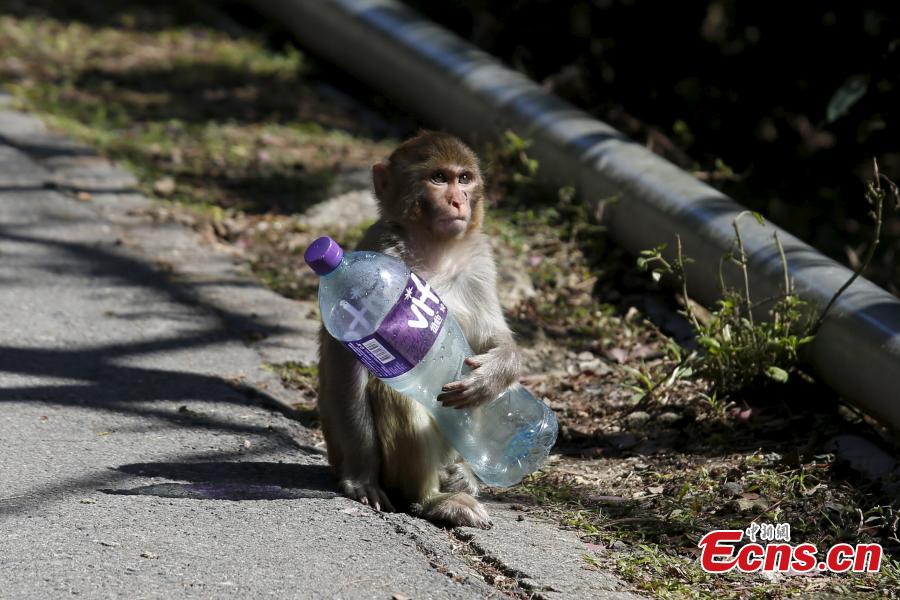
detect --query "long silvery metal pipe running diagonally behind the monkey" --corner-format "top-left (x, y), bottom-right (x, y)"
top-left (251, 0), bottom-right (900, 429)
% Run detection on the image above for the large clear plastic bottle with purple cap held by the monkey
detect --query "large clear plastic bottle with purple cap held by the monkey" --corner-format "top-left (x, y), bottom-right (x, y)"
top-left (305, 237), bottom-right (558, 487)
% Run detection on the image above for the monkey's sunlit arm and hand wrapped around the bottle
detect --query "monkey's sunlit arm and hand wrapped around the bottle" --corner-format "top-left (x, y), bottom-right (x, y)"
top-left (438, 261), bottom-right (520, 408)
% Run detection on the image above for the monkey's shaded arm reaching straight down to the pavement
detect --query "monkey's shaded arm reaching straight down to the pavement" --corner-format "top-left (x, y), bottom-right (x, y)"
top-left (318, 330), bottom-right (394, 511)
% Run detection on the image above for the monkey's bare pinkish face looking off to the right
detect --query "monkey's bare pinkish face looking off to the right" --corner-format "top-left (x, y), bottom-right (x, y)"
top-left (419, 165), bottom-right (481, 238)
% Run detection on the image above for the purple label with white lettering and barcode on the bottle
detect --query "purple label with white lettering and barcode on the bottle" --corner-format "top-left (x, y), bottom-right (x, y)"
top-left (344, 273), bottom-right (447, 379)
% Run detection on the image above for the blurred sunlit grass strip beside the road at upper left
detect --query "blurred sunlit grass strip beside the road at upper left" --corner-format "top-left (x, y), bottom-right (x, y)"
top-left (0, 8), bottom-right (388, 213)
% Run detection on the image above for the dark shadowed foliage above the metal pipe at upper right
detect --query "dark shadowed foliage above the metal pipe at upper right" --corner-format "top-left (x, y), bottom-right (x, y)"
top-left (407, 0), bottom-right (900, 294)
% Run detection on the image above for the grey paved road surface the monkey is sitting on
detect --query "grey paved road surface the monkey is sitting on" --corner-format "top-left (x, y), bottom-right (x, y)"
top-left (0, 97), bottom-right (640, 598)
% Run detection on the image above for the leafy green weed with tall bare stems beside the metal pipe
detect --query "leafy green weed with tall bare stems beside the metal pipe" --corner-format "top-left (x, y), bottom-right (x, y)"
top-left (637, 164), bottom-right (898, 396)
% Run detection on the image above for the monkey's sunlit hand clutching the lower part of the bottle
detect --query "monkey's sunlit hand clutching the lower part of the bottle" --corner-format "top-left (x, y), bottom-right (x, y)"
top-left (437, 344), bottom-right (519, 408)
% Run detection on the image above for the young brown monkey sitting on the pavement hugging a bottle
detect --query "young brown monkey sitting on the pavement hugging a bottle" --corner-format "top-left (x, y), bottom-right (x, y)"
top-left (319, 132), bottom-right (519, 528)
